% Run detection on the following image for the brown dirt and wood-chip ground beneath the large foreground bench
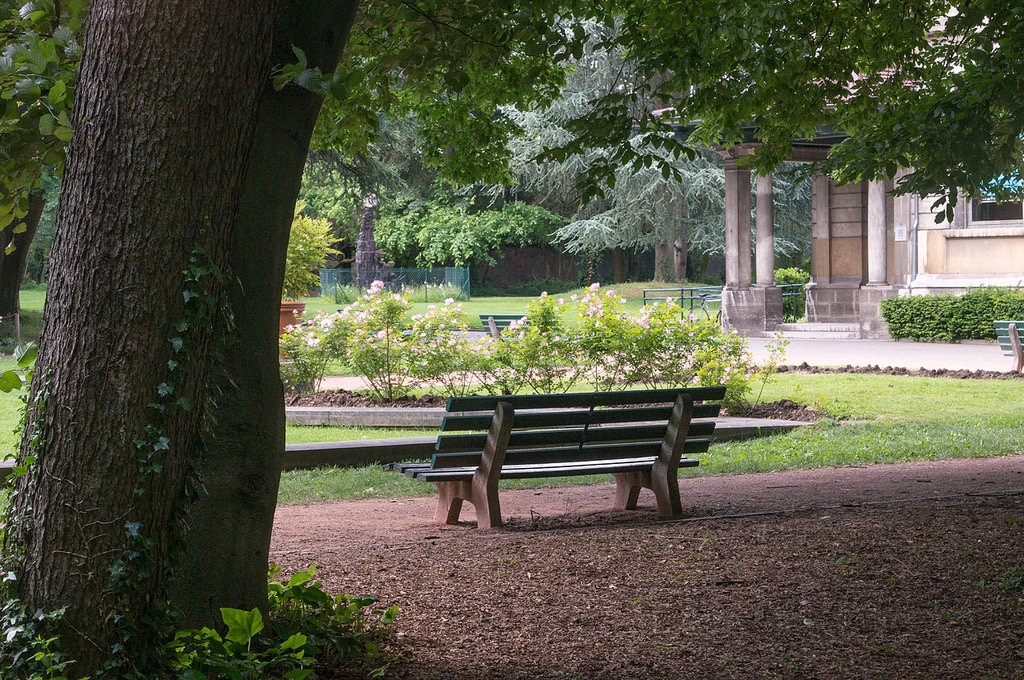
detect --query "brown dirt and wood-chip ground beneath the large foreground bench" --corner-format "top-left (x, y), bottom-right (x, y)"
top-left (270, 456), bottom-right (1024, 680)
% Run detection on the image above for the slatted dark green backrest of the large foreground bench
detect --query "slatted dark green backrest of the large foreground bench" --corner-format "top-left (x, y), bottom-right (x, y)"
top-left (431, 386), bottom-right (725, 468)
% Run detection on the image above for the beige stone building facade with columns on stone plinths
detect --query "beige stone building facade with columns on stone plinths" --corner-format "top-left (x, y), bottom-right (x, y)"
top-left (723, 146), bottom-right (1024, 338)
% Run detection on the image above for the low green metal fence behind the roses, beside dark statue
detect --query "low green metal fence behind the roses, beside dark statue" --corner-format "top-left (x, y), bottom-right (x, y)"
top-left (321, 267), bottom-right (470, 304)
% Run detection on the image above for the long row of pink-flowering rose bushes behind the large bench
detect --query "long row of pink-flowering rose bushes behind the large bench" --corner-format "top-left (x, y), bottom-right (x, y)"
top-left (282, 282), bottom-right (784, 407)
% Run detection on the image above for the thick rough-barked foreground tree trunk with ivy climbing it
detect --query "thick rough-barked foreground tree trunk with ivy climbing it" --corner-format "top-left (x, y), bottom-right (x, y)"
top-left (4, 0), bottom-right (278, 675)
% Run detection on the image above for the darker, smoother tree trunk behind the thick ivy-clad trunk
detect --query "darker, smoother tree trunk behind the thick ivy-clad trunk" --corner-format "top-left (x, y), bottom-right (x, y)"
top-left (172, 0), bottom-right (357, 626)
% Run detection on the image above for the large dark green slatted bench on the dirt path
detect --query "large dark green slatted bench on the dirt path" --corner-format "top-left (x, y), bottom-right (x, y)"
top-left (384, 386), bottom-right (725, 528)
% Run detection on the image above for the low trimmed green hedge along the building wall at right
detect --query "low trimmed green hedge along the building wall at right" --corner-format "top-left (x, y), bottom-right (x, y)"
top-left (882, 288), bottom-right (1024, 342)
